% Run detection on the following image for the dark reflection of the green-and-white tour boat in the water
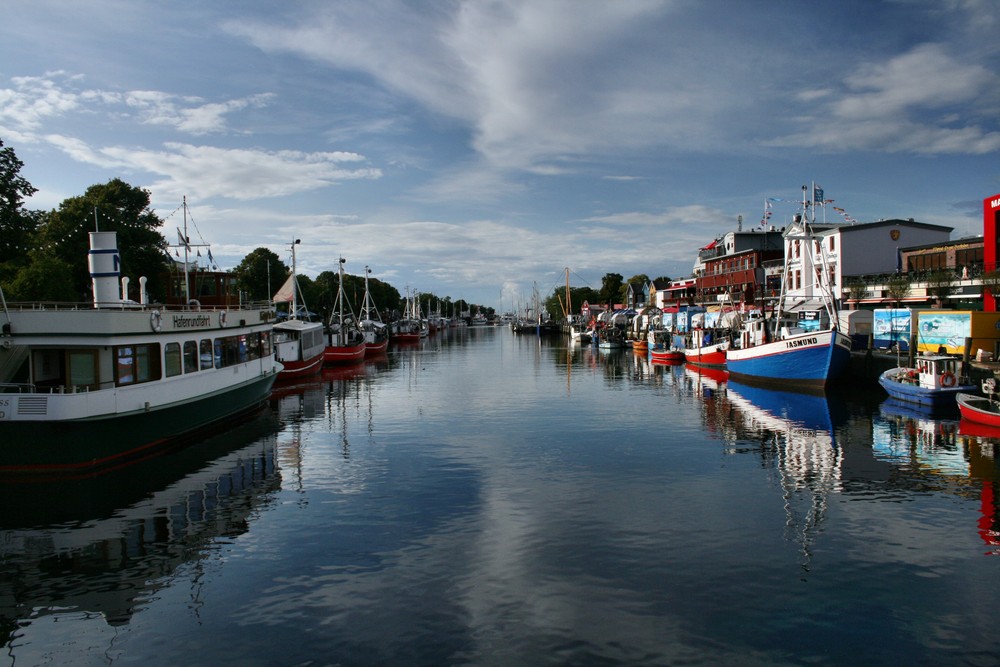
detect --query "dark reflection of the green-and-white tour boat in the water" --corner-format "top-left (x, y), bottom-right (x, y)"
top-left (0, 410), bottom-right (281, 640)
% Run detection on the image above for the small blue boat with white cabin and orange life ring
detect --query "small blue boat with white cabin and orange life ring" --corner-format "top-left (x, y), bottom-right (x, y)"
top-left (878, 354), bottom-right (978, 407)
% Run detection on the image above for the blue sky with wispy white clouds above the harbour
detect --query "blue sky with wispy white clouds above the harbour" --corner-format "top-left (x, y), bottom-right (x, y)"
top-left (0, 0), bottom-right (1000, 310)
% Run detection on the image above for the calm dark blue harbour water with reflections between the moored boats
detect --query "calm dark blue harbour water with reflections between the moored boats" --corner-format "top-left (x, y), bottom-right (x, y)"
top-left (0, 328), bottom-right (1000, 666)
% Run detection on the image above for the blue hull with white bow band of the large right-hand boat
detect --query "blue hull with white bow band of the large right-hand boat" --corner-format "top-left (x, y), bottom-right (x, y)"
top-left (726, 330), bottom-right (851, 387)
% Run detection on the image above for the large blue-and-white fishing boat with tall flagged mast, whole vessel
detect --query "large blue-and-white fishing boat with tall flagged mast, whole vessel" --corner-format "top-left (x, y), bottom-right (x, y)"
top-left (726, 184), bottom-right (851, 388)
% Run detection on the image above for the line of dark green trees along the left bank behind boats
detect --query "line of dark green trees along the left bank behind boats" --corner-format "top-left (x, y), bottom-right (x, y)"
top-left (0, 139), bottom-right (495, 318)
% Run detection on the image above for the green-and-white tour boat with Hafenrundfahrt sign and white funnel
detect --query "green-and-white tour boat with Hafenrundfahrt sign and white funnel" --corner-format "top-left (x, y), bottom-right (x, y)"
top-left (0, 232), bottom-right (281, 477)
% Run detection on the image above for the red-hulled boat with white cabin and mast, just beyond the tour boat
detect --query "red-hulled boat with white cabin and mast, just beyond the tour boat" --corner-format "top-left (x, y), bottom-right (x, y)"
top-left (274, 239), bottom-right (326, 380)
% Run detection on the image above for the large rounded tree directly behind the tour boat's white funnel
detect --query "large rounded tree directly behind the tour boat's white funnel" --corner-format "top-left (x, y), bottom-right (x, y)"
top-left (36, 178), bottom-right (170, 301)
